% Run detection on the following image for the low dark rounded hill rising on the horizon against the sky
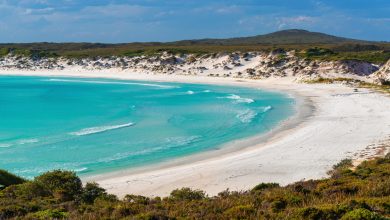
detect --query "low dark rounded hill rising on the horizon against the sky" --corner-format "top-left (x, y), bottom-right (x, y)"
top-left (172, 29), bottom-right (372, 45)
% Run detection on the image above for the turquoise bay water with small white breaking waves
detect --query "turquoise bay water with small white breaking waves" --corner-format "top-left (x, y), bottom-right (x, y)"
top-left (0, 76), bottom-right (294, 178)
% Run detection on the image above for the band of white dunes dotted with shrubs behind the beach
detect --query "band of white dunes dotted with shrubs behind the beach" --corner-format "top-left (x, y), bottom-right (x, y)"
top-left (0, 49), bottom-right (384, 80)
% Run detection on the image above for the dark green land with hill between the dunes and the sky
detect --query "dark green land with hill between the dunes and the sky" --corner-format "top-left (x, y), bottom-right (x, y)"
top-left (0, 30), bottom-right (390, 64)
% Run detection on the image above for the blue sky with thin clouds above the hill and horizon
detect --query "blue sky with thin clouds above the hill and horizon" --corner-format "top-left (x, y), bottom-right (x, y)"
top-left (0, 0), bottom-right (390, 43)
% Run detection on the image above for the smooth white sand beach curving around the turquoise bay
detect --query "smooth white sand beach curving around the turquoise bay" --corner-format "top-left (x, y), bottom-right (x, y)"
top-left (2, 71), bottom-right (390, 196)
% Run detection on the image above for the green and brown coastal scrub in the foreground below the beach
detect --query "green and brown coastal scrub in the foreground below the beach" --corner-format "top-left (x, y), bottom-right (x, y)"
top-left (0, 154), bottom-right (390, 219)
